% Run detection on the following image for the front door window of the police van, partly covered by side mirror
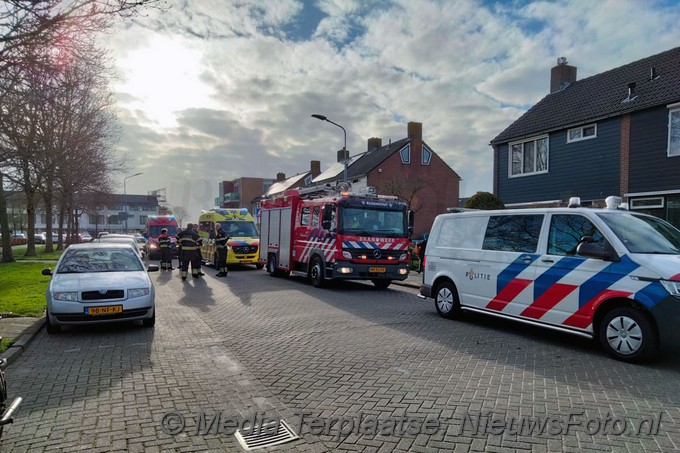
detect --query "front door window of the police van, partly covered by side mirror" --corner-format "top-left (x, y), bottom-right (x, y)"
top-left (548, 214), bottom-right (605, 256)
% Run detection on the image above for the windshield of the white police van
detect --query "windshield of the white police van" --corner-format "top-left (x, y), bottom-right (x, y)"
top-left (597, 213), bottom-right (680, 255)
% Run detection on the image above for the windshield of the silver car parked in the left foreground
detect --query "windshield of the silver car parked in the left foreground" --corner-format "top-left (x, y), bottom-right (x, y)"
top-left (56, 248), bottom-right (144, 274)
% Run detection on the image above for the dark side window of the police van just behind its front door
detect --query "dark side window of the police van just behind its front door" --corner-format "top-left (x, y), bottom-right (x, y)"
top-left (482, 214), bottom-right (543, 253)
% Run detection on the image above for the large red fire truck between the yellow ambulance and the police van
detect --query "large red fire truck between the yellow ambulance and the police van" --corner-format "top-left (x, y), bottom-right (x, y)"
top-left (260, 188), bottom-right (414, 289)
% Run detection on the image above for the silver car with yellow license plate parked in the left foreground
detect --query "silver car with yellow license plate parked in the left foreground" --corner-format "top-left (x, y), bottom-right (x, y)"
top-left (42, 242), bottom-right (158, 333)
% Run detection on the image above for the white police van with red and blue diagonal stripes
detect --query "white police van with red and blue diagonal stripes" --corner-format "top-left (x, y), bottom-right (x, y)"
top-left (418, 197), bottom-right (680, 362)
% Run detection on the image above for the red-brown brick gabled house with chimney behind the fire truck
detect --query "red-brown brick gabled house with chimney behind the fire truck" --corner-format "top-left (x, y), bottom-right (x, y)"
top-left (312, 122), bottom-right (461, 235)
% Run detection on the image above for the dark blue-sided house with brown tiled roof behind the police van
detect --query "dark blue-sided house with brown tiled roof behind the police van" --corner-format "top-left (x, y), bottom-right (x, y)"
top-left (491, 47), bottom-right (680, 226)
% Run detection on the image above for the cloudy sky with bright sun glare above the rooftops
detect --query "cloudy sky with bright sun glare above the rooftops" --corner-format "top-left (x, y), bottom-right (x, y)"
top-left (109, 0), bottom-right (680, 221)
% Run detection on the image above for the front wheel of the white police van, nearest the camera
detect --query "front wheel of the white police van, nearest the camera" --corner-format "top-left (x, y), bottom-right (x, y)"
top-left (599, 307), bottom-right (659, 362)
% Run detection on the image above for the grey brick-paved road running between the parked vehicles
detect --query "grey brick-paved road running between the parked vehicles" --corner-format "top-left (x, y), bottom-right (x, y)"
top-left (0, 269), bottom-right (680, 452)
